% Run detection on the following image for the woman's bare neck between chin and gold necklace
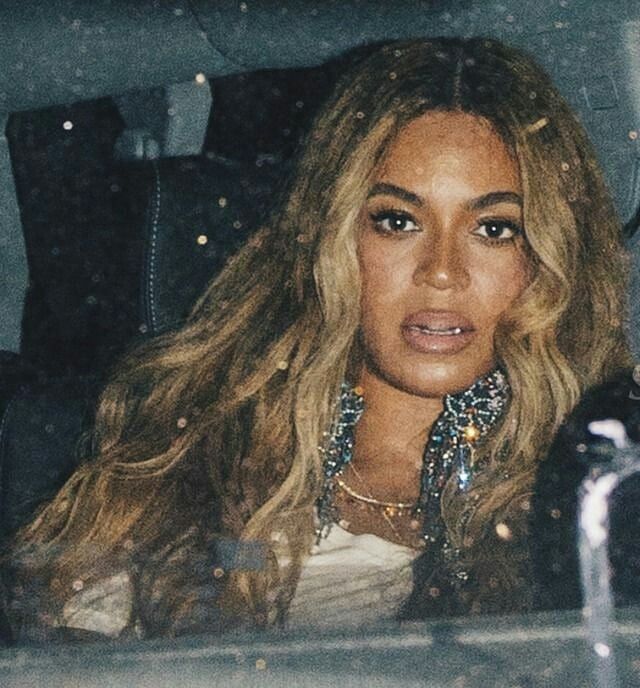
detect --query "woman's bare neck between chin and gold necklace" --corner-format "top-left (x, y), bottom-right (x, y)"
top-left (353, 367), bottom-right (442, 498)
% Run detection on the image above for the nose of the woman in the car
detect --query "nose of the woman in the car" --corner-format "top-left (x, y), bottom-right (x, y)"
top-left (413, 231), bottom-right (469, 290)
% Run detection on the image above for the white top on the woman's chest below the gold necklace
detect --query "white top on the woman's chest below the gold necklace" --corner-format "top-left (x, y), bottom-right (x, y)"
top-left (287, 524), bottom-right (416, 629)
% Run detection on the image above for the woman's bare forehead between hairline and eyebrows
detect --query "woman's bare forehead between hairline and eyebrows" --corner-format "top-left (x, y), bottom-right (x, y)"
top-left (377, 112), bottom-right (521, 195)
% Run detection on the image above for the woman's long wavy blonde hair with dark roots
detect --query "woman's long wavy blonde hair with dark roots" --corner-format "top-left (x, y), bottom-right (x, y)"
top-left (8, 39), bottom-right (629, 628)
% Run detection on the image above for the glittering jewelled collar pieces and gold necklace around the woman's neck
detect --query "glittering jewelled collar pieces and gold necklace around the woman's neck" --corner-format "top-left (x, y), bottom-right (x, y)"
top-left (316, 369), bottom-right (510, 552)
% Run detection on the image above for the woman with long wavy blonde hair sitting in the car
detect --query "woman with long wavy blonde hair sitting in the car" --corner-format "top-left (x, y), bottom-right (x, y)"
top-left (5, 39), bottom-right (629, 635)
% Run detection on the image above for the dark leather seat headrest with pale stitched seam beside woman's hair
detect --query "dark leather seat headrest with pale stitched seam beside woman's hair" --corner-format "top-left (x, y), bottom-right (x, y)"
top-left (127, 157), bottom-right (277, 334)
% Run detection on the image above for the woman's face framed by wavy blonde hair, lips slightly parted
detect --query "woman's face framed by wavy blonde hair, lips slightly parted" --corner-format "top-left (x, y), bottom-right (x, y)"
top-left (359, 112), bottom-right (527, 397)
